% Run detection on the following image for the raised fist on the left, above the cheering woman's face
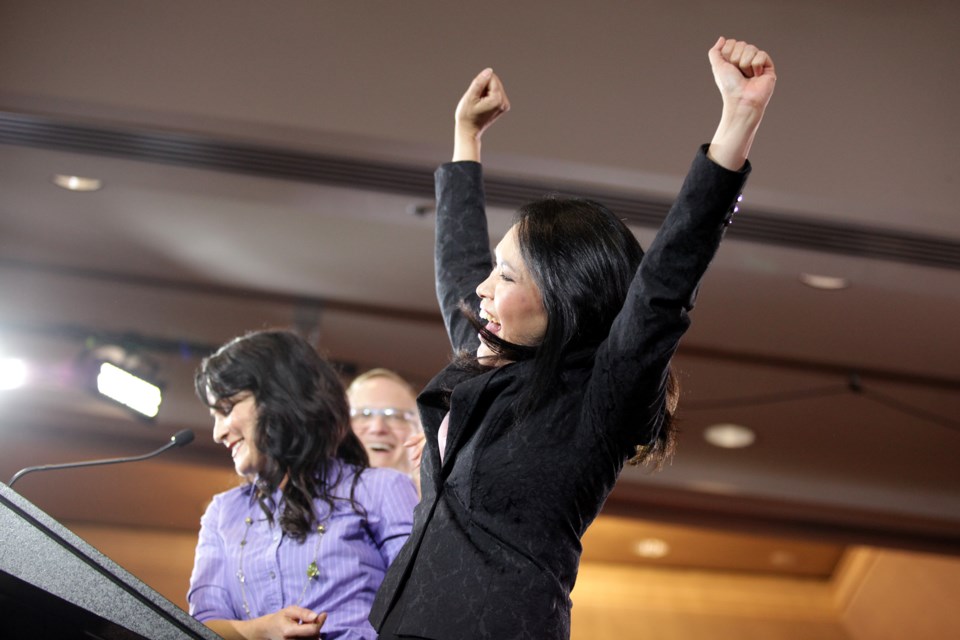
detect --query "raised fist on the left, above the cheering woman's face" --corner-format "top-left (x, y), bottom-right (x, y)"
top-left (453, 68), bottom-right (510, 162)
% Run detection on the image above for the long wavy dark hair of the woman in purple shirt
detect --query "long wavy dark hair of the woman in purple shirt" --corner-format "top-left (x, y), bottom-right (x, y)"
top-left (194, 331), bottom-right (369, 541)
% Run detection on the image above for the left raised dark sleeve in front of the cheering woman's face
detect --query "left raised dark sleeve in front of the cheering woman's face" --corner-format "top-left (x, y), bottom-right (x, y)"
top-left (434, 162), bottom-right (493, 352)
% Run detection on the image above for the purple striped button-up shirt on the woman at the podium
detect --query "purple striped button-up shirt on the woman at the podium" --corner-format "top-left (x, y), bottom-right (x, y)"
top-left (187, 465), bottom-right (417, 640)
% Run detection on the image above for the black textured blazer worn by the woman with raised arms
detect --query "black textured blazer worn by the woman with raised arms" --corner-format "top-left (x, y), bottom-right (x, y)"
top-left (370, 147), bottom-right (749, 640)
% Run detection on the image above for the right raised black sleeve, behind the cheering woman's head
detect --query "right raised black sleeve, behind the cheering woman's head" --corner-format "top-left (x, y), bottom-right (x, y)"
top-left (584, 145), bottom-right (750, 445)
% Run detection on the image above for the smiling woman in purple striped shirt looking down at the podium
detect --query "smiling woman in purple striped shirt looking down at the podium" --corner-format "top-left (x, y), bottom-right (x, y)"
top-left (187, 331), bottom-right (417, 639)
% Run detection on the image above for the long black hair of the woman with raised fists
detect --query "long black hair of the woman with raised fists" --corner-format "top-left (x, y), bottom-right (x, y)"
top-left (465, 197), bottom-right (679, 466)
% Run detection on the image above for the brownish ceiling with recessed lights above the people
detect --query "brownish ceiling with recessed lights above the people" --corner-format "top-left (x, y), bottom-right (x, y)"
top-left (0, 0), bottom-right (960, 570)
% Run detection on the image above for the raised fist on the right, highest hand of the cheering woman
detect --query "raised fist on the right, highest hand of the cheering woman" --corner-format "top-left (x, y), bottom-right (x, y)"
top-left (707, 38), bottom-right (777, 171)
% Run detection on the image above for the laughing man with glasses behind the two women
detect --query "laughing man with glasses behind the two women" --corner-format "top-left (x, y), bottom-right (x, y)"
top-left (347, 369), bottom-right (423, 493)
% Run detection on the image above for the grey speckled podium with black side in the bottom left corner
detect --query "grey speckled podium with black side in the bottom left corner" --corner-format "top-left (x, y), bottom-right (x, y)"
top-left (0, 483), bottom-right (220, 640)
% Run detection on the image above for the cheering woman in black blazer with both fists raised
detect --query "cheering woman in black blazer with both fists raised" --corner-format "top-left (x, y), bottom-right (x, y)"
top-left (370, 38), bottom-right (776, 640)
